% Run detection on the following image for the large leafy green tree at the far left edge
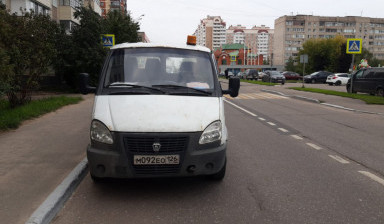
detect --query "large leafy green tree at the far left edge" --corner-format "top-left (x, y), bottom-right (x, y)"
top-left (0, 9), bottom-right (59, 107)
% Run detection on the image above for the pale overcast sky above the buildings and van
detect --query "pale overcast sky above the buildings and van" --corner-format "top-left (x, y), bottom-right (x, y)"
top-left (127, 0), bottom-right (384, 44)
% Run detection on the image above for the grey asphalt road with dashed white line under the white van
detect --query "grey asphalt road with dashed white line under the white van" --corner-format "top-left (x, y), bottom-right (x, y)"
top-left (52, 84), bottom-right (384, 224)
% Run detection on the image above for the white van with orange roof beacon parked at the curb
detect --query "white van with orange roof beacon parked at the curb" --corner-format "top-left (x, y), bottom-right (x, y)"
top-left (80, 37), bottom-right (240, 182)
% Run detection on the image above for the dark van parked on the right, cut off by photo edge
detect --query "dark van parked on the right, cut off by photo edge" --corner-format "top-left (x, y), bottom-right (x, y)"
top-left (347, 68), bottom-right (384, 97)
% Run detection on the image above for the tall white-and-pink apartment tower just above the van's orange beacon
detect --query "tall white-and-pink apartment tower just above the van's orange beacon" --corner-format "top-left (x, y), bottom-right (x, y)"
top-left (193, 15), bottom-right (226, 50)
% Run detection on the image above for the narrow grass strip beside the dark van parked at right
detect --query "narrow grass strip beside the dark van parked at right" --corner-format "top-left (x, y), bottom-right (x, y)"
top-left (289, 87), bottom-right (384, 105)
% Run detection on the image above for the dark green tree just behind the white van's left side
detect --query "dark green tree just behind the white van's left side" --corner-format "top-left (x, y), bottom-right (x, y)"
top-left (56, 6), bottom-right (140, 88)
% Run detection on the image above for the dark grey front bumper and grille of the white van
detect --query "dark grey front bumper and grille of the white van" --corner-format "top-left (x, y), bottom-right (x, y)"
top-left (87, 132), bottom-right (226, 178)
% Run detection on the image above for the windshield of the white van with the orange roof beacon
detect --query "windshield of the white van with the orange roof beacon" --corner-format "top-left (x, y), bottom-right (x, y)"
top-left (104, 47), bottom-right (214, 90)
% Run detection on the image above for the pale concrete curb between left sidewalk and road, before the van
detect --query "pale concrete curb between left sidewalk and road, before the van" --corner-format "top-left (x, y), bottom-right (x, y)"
top-left (25, 158), bottom-right (88, 224)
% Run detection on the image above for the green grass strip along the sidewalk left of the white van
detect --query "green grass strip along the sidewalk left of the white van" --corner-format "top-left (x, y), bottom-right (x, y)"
top-left (0, 96), bottom-right (82, 131)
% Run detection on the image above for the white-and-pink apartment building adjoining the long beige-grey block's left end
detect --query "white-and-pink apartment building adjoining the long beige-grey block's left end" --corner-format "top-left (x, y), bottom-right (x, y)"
top-left (226, 25), bottom-right (274, 60)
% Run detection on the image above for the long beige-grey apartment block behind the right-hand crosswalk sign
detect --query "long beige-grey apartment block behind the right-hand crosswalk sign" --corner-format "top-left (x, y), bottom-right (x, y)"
top-left (273, 15), bottom-right (384, 65)
